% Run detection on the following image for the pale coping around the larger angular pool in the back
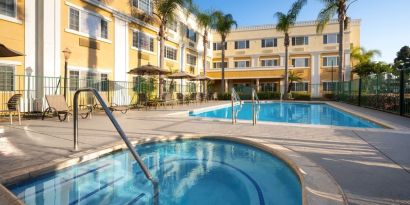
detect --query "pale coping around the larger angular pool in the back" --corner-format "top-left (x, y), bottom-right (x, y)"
top-left (187, 100), bottom-right (399, 131)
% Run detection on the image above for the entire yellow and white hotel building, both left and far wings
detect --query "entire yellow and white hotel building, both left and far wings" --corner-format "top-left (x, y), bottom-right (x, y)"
top-left (0, 0), bottom-right (360, 110)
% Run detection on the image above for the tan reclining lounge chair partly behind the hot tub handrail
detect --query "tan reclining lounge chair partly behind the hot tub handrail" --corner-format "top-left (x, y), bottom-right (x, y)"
top-left (41, 95), bottom-right (92, 122)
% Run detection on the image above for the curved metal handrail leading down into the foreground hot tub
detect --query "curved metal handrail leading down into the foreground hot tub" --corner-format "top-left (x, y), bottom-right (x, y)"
top-left (73, 88), bottom-right (159, 205)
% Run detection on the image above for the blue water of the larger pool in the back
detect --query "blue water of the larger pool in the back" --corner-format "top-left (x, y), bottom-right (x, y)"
top-left (190, 102), bottom-right (381, 128)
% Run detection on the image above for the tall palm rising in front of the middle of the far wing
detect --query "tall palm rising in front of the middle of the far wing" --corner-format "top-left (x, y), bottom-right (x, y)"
top-left (275, 0), bottom-right (307, 100)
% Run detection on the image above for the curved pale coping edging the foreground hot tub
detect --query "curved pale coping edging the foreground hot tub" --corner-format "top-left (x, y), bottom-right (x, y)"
top-left (0, 134), bottom-right (348, 205)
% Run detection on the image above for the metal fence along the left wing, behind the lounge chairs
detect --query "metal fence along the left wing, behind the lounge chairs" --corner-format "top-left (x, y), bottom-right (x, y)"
top-left (0, 75), bottom-right (202, 112)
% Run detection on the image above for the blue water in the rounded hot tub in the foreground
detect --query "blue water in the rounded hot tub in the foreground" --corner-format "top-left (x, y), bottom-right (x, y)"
top-left (8, 139), bottom-right (302, 205)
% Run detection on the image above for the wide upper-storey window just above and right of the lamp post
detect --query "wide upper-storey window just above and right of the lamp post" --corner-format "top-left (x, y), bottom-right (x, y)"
top-left (69, 8), bottom-right (108, 39)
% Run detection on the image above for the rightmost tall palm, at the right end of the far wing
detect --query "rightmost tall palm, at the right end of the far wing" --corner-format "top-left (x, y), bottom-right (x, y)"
top-left (316, 0), bottom-right (358, 82)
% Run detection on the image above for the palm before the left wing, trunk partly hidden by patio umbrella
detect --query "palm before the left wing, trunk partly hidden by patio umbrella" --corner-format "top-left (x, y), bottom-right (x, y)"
top-left (130, 0), bottom-right (193, 96)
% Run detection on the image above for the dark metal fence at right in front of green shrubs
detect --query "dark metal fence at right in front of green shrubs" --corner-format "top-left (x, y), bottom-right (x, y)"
top-left (333, 71), bottom-right (410, 117)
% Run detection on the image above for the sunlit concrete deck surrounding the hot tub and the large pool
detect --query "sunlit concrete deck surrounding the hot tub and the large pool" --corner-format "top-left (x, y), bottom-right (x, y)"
top-left (0, 102), bottom-right (410, 204)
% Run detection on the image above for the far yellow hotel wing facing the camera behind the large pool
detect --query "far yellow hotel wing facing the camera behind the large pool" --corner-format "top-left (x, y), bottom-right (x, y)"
top-left (207, 20), bottom-right (360, 97)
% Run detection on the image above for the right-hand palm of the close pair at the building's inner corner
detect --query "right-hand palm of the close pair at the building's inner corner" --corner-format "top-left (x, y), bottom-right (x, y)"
top-left (212, 11), bottom-right (238, 93)
